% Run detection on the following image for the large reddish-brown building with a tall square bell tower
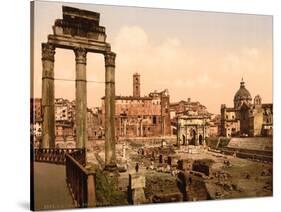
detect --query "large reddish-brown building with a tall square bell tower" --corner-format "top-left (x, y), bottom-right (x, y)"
top-left (102, 73), bottom-right (171, 137)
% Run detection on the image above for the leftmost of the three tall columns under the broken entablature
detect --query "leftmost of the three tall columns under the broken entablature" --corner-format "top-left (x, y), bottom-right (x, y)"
top-left (42, 43), bottom-right (55, 148)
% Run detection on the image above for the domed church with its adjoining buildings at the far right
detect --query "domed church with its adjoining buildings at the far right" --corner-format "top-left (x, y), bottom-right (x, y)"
top-left (221, 79), bottom-right (273, 137)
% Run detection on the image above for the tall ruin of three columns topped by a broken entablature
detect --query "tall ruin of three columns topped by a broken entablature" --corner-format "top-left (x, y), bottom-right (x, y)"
top-left (42, 6), bottom-right (116, 169)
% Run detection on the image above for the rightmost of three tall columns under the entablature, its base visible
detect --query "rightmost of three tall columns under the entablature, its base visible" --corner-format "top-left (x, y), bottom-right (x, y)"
top-left (104, 52), bottom-right (117, 171)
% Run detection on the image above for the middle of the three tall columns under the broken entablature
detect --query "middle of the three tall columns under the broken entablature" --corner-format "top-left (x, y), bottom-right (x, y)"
top-left (74, 48), bottom-right (88, 148)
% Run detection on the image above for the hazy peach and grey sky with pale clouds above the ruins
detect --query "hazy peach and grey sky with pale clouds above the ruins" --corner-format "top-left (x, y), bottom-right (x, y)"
top-left (33, 1), bottom-right (273, 114)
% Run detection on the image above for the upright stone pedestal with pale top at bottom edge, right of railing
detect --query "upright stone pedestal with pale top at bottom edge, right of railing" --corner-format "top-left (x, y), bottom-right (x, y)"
top-left (128, 173), bottom-right (146, 205)
